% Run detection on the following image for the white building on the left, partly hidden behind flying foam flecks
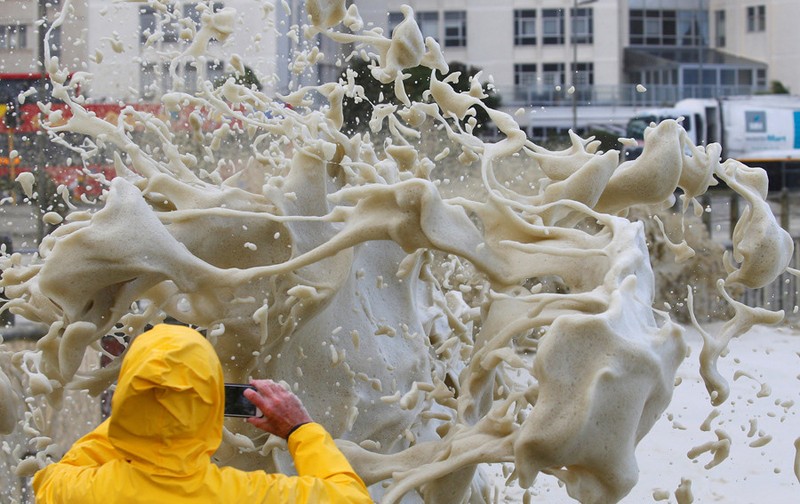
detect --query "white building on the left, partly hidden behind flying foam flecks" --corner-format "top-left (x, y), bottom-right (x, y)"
top-left (0, 0), bottom-right (386, 102)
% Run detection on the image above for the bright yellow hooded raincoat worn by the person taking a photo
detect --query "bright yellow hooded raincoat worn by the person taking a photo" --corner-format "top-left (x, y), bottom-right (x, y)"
top-left (33, 324), bottom-right (372, 504)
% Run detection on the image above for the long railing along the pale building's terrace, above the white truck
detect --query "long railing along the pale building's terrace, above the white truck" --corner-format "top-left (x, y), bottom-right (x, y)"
top-left (497, 84), bottom-right (767, 107)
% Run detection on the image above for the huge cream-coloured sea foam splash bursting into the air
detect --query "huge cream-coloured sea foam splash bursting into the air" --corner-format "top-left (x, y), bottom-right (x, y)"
top-left (0, 0), bottom-right (792, 503)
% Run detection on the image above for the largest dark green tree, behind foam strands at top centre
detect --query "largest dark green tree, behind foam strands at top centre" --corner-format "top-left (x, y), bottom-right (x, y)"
top-left (342, 58), bottom-right (500, 134)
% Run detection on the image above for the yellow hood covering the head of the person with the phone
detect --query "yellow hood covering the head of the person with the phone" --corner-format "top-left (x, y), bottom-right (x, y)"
top-left (108, 324), bottom-right (225, 475)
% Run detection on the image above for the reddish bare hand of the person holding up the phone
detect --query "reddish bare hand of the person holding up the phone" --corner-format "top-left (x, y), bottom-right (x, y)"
top-left (244, 380), bottom-right (312, 439)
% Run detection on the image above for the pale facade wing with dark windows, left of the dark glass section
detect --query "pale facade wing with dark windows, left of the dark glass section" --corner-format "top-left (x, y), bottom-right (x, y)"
top-left (387, 0), bottom-right (625, 104)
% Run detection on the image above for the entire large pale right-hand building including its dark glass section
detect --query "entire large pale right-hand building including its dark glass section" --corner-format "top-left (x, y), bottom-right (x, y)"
top-left (387, 0), bottom-right (788, 137)
